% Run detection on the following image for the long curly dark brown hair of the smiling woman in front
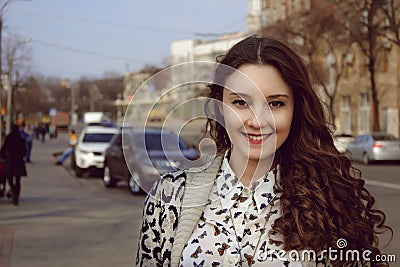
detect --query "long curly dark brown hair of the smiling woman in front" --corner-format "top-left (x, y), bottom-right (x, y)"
top-left (206, 36), bottom-right (392, 266)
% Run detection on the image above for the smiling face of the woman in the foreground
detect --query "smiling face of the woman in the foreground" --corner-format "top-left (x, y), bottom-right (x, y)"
top-left (221, 64), bottom-right (294, 164)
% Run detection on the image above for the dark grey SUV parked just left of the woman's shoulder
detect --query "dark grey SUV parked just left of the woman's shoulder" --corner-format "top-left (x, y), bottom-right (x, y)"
top-left (103, 128), bottom-right (198, 194)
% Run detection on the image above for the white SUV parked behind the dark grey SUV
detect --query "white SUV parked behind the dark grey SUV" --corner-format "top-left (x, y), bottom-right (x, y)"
top-left (74, 126), bottom-right (118, 177)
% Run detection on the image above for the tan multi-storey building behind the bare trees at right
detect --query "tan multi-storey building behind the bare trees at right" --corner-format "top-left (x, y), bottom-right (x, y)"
top-left (255, 0), bottom-right (400, 137)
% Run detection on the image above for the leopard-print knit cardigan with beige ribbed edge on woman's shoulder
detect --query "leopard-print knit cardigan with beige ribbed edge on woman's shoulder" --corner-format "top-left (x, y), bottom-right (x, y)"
top-left (136, 156), bottom-right (223, 267)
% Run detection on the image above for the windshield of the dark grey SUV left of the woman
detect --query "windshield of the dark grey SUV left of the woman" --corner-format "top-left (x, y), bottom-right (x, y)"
top-left (134, 133), bottom-right (186, 151)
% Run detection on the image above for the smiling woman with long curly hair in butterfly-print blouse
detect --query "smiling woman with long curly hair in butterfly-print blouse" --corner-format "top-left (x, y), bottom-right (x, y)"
top-left (136, 36), bottom-right (391, 267)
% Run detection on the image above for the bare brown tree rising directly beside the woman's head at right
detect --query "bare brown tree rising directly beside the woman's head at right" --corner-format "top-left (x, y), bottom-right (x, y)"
top-left (263, 3), bottom-right (352, 125)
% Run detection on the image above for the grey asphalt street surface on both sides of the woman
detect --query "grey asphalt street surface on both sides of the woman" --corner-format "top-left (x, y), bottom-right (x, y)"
top-left (0, 133), bottom-right (400, 267)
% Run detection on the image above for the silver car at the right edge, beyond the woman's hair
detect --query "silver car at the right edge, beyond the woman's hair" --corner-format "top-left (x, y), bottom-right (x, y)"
top-left (346, 132), bottom-right (400, 164)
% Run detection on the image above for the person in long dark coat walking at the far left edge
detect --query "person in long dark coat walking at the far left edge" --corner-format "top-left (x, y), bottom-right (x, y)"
top-left (0, 125), bottom-right (27, 205)
